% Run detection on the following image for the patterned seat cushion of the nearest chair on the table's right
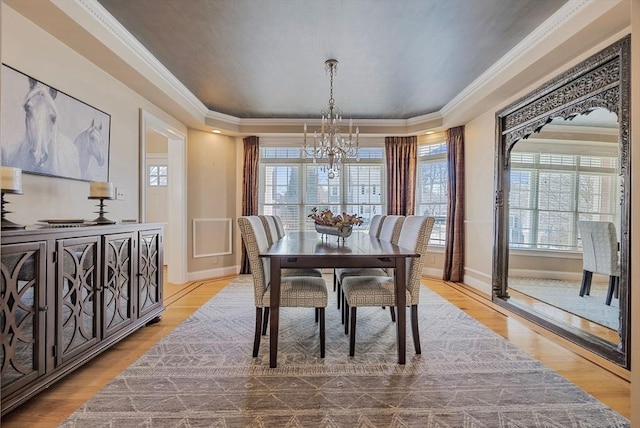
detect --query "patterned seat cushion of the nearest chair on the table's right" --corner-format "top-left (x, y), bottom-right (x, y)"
top-left (342, 276), bottom-right (417, 307)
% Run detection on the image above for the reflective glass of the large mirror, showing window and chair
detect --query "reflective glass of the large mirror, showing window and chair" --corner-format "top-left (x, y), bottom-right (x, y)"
top-left (508, 108), bottom-right (622, 344)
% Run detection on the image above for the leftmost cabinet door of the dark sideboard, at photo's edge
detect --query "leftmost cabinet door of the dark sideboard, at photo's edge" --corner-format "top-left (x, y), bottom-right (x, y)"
top-left (0, 242), bottom-right (47, 399)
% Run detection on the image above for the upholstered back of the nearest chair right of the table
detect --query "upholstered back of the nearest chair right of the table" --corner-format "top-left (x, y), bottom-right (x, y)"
top-left (398, 215), bottom-right (436, 298)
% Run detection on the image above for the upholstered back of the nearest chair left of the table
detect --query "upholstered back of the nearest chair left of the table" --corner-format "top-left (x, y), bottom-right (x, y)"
top-left (238, 216), bottom-right (271, 307)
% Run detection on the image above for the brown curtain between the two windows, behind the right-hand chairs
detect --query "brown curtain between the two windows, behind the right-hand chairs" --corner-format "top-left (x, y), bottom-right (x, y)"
top-left (384, 135), bottom-right (418, 215)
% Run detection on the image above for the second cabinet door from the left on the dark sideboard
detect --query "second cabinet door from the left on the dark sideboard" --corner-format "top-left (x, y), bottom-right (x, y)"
top-left (56, 236), bottom-right (102, 364)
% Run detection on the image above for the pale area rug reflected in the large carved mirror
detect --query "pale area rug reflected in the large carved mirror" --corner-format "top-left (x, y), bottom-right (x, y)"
top-left (509, 277), bottom-right (620, 330)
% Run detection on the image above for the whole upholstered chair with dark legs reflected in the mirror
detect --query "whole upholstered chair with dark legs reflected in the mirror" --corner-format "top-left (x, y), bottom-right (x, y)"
top-left (578, 221), bottom-right (620, 306)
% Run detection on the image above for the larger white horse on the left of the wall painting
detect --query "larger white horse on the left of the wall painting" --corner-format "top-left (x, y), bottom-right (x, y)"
top-left (4, 78), bottom-right (80, 178)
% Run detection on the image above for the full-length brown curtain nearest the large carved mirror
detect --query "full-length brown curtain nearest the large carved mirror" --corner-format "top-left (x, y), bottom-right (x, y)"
top-left (442, 126), bottom-right (464, 282)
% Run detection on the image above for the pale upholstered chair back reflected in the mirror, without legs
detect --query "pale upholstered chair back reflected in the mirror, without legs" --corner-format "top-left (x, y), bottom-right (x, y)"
top-left (578, 221), bottom-right (620, 276)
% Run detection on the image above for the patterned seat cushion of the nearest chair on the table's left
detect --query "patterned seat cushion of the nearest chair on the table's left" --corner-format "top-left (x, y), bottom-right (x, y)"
top-left (256, 276), bottom-right (327, 308)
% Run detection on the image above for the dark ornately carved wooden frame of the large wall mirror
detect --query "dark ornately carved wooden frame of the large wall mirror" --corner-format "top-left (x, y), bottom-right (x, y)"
top-left (492, 36), bottom-right (631, 368)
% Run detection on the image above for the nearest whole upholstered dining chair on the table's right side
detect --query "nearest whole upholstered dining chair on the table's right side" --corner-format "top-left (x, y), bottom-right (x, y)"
top-left (342, 216), bottom-right (435, 356)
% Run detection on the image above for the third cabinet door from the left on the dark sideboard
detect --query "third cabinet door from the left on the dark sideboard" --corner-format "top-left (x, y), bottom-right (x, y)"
top-left (102, 233), bottom-right (134, 338)
